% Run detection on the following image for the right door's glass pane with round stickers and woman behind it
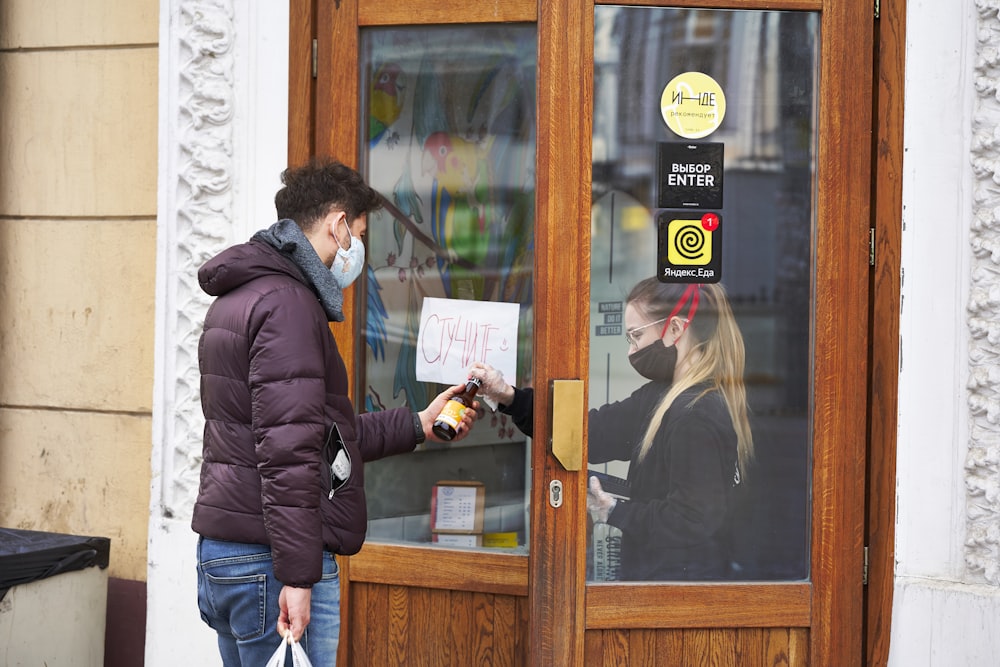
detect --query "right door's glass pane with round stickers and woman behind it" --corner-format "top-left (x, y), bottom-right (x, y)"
top-left (588, 6), bottom-right (818, 581)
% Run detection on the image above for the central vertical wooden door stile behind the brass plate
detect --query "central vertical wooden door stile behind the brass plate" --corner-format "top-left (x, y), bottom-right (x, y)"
top-left (528, 0), bottom-right (594, 665)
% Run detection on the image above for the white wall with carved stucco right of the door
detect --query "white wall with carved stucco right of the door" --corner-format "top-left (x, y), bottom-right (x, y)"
top-left (896, 0), bottom-right (1000, 667)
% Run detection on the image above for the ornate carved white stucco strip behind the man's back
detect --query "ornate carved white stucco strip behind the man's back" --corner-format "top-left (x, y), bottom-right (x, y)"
top-left (154, 0), bottom-right (236, 519)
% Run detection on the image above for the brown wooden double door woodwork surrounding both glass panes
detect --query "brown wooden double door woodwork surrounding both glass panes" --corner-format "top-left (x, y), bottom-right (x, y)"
top-left (289, 0), bottom-right (872, 666)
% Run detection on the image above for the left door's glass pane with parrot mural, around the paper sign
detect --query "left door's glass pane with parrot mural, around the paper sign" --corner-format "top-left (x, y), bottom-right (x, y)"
top-left (359, 24), bottom-right (537, 553)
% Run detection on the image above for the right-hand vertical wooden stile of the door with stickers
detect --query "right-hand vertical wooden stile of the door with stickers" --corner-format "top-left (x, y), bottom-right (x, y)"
top-left (810, 0), bottom-right (873, 667)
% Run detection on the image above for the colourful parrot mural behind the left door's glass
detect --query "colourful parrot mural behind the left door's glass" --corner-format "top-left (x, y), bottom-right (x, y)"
top-left (366, 38), bottom-right (535, 418)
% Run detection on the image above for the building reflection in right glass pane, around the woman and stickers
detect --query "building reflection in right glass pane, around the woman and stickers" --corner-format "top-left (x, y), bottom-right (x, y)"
top-left (590, 6), bottom-right (818, 579)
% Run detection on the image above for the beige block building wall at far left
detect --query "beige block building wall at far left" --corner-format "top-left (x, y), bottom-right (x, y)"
top-left (0, 0), bottom-right (159, 581)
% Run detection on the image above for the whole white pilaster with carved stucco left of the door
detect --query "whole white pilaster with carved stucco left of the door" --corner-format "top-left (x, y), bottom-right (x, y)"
top-left (145, 0), bottom-right (288, 667)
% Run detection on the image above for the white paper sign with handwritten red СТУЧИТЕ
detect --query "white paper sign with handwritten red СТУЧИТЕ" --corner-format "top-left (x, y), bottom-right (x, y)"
top-left (416, 297), bottom-right (520, 384)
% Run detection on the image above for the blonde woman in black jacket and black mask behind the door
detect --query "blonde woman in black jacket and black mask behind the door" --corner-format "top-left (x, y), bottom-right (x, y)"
top-left (470, 278), bottom-right (753, 580)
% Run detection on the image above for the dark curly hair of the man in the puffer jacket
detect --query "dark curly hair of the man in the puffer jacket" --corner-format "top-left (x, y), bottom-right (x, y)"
top-left (274, 158), bottom-right (382, 232)
